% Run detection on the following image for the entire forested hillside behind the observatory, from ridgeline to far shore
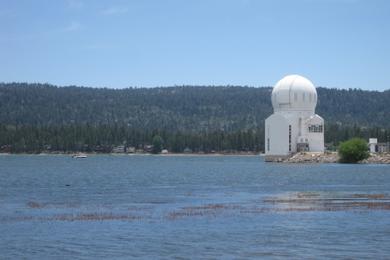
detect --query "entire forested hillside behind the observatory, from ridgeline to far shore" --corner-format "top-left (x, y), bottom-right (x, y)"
top-left (0, 83), bottom-right (390, 152)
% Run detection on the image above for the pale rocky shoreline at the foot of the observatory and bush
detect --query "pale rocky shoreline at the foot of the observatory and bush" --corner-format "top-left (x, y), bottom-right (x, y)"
top-left (281, 152), bottom-right (390, 164)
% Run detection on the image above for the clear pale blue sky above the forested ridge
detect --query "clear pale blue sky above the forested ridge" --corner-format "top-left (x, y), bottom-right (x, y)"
top-left (0, 0), bottom-right (390, 90)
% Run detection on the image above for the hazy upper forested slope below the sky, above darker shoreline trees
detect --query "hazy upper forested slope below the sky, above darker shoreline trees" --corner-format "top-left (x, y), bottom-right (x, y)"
top-left (0, 83), bottom-right (390, 131)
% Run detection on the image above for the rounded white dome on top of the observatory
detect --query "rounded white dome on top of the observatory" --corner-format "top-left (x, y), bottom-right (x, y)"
top-left (272, 75), bottom-right (317, 112)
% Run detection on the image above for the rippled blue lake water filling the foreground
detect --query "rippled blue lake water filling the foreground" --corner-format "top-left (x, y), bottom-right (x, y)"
top-left (0, 155), bottom-right (390, 259)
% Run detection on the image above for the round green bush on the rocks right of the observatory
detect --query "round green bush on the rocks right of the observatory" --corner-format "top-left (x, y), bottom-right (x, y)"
top-left (339, 138), bottom-right (370, 163)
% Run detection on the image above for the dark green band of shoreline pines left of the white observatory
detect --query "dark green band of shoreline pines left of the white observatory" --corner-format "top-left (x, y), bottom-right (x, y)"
top-left (0, 124), bottom-right (264, 153)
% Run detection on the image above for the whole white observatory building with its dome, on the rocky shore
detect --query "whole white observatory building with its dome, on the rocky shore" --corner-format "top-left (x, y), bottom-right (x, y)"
top-left (265, 75), bottom-right (324, 161)
